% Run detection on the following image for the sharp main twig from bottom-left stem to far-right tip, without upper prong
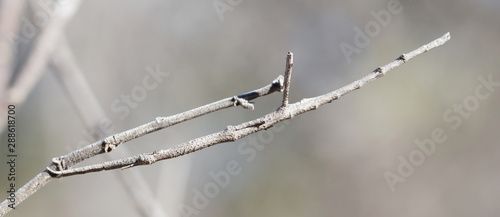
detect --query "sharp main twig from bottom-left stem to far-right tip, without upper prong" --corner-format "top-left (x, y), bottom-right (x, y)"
top-left (0, 33), bottom-right (450, 216)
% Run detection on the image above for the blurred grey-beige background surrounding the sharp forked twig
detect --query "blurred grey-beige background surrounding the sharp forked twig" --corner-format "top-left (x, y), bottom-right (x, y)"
top-left (0, 0), bottom-right (500, 217)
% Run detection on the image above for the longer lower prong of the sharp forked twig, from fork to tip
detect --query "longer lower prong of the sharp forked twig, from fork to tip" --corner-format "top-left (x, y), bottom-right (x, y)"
top-left (43, 33), bottom-right (450, 177)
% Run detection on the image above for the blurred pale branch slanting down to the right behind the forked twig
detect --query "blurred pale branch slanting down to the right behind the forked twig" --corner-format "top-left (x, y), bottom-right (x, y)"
top-left (52, 36), bottom-right (173, 217)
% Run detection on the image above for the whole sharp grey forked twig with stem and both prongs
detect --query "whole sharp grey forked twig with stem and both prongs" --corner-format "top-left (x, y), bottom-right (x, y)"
top-left (0, 33), bottom-right (450, 216)
